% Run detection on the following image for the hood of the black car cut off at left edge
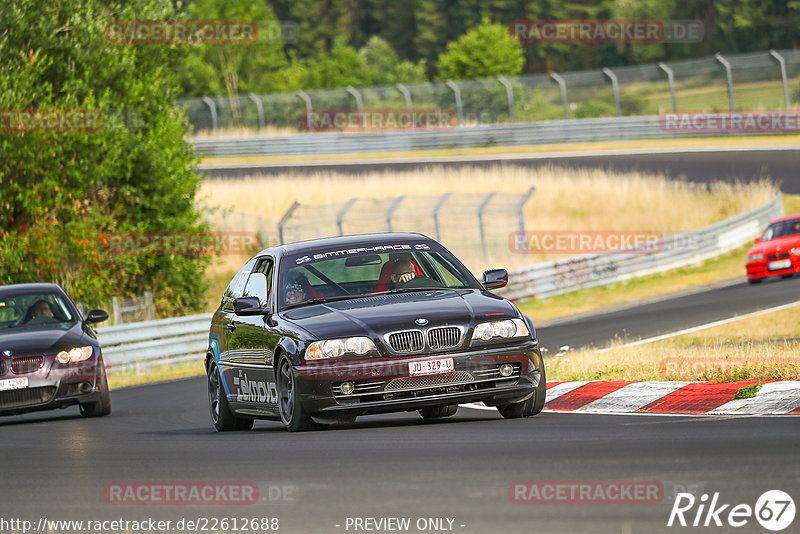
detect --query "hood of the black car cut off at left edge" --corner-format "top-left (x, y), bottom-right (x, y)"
top-left (0, 322), bottom-right (95, 354)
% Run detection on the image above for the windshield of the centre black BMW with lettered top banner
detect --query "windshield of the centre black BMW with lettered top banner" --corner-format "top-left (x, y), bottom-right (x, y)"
top-left (279, 242), bottom-right (480, 309)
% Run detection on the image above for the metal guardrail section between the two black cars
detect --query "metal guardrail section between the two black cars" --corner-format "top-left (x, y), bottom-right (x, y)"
top-left (97, 313), bottom-right (213, 373)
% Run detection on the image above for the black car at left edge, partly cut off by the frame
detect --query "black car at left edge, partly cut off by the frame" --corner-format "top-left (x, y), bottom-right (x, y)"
top-left (0, 284), bottom-right (111, 417)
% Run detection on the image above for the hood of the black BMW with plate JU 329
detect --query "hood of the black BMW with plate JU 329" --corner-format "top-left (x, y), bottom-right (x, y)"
top-left (283, 289), bottom-right (520, 339)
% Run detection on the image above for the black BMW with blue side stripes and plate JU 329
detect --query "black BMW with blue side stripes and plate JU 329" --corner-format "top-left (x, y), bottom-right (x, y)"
top-left (205, 233), bottom-right (546, 431)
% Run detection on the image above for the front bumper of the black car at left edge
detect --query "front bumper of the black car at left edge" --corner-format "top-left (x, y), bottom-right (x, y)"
top-left (0, 357), bottom-right (100, 416)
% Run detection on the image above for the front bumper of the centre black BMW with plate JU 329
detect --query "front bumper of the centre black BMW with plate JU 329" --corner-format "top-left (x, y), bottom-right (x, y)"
top-left (295, 340), bottom-right (542, 417)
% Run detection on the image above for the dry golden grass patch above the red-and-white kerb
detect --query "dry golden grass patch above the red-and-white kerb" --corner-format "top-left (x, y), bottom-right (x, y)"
top-left (546, 308), bottom-right (800, 382)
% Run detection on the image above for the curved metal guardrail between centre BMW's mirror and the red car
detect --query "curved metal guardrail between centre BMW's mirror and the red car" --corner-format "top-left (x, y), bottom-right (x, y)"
top-left (496, 193), bottom-right (783, 300)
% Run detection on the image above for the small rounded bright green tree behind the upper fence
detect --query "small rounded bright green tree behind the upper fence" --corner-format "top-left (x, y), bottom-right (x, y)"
top-left (438, 19), bottom-right (525, 80)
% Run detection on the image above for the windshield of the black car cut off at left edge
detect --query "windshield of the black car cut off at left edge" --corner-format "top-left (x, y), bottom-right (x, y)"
top-left (0, 293), bottom-right (75, 328)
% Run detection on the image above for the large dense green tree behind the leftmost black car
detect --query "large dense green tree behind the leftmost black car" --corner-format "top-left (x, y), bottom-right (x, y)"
top-left (0, 0), bottom-right (207, 313)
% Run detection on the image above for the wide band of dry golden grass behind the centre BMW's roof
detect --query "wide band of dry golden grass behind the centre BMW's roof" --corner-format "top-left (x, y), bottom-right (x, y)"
top-left (198, 165), bottom-right (774, 272)
